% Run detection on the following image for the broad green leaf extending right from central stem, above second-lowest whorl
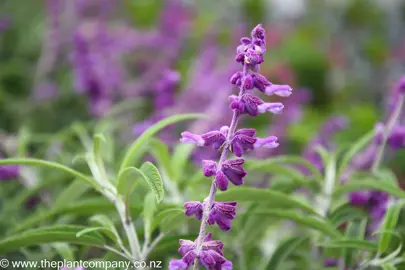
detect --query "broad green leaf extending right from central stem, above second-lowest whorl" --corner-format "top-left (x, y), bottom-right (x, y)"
top-left (215, 187), bottom-right (316, 214)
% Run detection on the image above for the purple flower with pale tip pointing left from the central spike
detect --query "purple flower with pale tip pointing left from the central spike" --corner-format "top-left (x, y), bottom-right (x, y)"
top-left (180, 127), bottom-right (228, 149)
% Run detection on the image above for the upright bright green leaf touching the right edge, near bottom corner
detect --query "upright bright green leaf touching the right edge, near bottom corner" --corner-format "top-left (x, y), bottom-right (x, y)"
top-left (378, 200), bottom-right (405, 253)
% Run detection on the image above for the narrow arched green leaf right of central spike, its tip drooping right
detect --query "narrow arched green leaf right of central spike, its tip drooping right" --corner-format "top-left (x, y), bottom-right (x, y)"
top-left (246, 156), bottom-right (323, 183)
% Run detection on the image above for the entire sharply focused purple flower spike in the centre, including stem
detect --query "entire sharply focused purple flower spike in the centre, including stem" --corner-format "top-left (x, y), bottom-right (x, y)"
top-left (169, 24), bottom-right (292, 270)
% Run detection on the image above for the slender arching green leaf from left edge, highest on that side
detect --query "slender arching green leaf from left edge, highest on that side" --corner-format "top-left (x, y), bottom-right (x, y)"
top-left (0, 158), bottom-right (98, 189)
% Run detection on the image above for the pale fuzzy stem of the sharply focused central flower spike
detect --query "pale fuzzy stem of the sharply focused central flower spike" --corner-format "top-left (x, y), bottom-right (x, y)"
top-left (193, 64), bottom-right (248, 270)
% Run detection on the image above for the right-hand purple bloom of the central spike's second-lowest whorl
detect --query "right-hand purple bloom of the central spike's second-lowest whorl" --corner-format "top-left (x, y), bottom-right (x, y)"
top-left (208, 202), bottom-right (237, 232)
